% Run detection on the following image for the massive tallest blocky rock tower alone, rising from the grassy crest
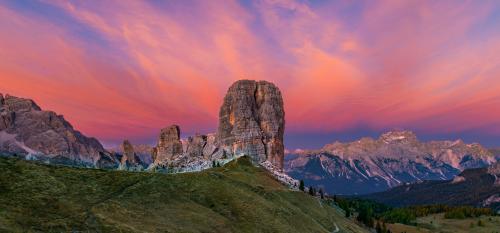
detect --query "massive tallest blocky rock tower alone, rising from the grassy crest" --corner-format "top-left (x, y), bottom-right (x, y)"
top-left (217, 80), bottom-right (285, 169)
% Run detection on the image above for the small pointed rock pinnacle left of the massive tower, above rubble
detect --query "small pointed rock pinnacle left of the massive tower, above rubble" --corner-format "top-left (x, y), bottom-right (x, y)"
top-left (153, 125), bottom-right (183, 163)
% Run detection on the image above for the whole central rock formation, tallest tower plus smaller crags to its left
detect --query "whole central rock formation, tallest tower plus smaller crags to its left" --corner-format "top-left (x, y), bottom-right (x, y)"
top-left (148, 80), bottom-right (285, 171)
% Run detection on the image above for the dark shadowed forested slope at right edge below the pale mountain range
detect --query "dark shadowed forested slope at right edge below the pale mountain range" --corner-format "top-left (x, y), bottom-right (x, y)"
top-left (363, 162), bottom-right (500, 210)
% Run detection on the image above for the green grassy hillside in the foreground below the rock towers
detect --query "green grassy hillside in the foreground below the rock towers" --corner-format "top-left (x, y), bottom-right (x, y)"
top-left (0, 158), bottom-right (365, 232)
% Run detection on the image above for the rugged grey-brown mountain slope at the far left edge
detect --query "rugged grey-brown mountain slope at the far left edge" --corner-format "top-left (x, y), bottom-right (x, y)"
top-left (0, 95), bottom-right (118, 166)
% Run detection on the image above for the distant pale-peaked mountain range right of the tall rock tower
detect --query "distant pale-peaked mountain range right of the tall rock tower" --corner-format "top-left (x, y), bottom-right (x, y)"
top-left (285, 131), bottom-right (497, 195)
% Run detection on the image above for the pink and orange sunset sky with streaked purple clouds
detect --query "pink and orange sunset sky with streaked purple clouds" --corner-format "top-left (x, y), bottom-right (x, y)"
top-left (0, 0), bottom-right (500, 149)
